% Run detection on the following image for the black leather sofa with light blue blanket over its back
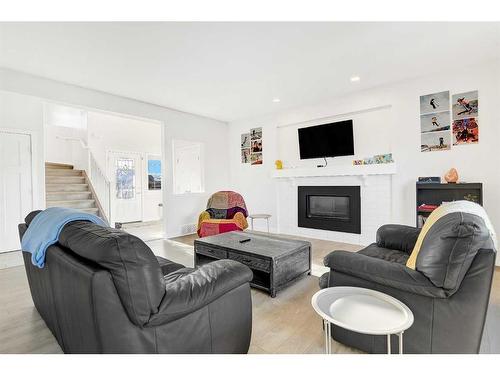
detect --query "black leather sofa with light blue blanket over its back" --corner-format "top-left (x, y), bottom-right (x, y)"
top-left (19, 211), bottom-right (252, 353)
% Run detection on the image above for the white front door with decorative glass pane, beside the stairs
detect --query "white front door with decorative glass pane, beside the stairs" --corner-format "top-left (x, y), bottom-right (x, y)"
top-left (108, 151), bottom-right (142, 223)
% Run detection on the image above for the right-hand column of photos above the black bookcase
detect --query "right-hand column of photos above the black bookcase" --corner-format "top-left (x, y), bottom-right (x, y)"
top-left (452, 90), bottom-right (479, 146)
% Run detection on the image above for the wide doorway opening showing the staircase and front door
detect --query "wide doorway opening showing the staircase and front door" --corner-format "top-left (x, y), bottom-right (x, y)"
top-left (44, 103), bottom-right (164, 241)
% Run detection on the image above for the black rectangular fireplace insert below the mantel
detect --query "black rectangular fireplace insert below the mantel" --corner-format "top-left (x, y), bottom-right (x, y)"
top-left (298, 186), bottom-right (361, 233)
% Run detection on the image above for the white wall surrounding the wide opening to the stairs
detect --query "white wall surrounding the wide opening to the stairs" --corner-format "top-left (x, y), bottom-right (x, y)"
top-left (0, 69), bottom-right (229, 237)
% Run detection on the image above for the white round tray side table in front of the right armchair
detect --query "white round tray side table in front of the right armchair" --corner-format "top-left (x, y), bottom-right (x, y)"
top-left (311, 286), bottom-right (413, 354)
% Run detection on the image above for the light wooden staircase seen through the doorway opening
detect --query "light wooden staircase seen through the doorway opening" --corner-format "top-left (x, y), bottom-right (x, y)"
top-left (45, 163), bottom-right (102, 219)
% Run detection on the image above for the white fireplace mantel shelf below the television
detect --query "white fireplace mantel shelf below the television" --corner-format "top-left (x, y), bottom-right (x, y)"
top-left (271, 163), bottom-right (397, 178)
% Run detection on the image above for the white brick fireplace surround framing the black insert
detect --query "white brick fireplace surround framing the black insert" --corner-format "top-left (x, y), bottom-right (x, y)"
top-left (273, 166), bottom-right (395, 245)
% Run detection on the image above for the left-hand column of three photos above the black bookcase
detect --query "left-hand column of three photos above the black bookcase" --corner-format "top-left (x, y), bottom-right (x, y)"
top-left (420, 91), bottom-right (451, 152)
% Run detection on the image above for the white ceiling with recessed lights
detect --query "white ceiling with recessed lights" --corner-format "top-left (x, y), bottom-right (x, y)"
top-left (0, 22), bottom-right (500, 121)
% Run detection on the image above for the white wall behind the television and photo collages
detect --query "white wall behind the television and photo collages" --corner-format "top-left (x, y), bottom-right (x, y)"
top-left (229, 62), bottom-right (500, 262)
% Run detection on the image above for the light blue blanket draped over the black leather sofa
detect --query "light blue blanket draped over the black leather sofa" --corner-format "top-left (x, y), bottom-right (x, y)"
top-left (21, 207), bottom-right (107, 268)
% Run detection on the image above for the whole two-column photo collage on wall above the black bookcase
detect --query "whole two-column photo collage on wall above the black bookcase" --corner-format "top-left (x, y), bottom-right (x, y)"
top-left (420, 91), bottom-right (479, 152)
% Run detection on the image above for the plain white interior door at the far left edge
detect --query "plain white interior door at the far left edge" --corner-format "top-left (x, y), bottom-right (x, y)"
top-left (0, 130), bottom-right (33, 252)
